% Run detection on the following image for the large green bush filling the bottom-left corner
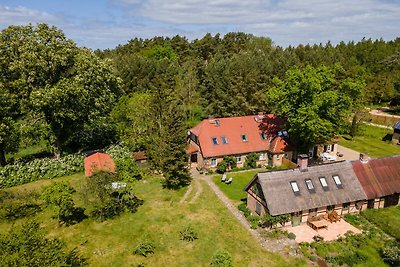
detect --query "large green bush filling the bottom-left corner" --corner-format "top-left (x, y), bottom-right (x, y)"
top-left (0, 222), bottom-right (86, 266)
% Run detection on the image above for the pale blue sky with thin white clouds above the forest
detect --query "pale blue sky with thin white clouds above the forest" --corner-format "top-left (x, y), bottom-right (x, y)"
top-left (0, 0), bottom-right (400, 49)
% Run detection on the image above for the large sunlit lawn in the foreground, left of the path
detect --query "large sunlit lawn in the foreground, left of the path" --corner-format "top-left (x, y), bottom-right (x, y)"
top-left (0, 173), bottom-right (305, 266)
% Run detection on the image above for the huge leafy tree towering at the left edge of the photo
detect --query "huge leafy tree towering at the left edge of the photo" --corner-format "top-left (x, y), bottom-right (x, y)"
top-left (0, 24), bottom-right (119, 161)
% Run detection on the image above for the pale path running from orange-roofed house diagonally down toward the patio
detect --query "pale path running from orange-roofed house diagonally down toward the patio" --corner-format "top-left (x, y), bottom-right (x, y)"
top-left (192, 171), bottom-right (297, 255)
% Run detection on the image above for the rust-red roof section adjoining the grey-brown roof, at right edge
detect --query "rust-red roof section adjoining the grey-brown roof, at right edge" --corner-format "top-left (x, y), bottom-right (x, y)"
top-left (352, 156), bottom-right (400, 199)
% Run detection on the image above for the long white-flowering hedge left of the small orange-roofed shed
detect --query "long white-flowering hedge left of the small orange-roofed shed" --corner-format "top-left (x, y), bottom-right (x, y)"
top-left (0, 154), bottom-right (84, 188)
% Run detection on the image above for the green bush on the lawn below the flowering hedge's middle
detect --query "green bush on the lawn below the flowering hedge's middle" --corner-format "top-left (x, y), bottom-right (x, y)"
top-left (41, 182), bottom-right (86, 225)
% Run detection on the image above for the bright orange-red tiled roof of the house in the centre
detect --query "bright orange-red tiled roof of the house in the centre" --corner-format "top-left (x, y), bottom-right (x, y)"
top-left (190, 114), bottom-right (287, 158)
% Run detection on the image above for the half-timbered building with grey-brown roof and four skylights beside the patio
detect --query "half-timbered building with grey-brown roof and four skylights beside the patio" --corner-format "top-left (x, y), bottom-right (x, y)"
top-left (245, 161), bottom-right (367, 226)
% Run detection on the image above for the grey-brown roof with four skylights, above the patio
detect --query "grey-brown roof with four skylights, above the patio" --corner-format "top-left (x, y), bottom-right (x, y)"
top-left (245, 161), bottom-right (366, 216)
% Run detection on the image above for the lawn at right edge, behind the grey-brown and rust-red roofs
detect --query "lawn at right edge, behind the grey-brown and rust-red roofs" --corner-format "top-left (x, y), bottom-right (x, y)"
top-left (339, 125), bottom-right (400, 158)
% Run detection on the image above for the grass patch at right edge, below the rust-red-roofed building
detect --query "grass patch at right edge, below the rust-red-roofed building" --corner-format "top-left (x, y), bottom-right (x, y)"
top-left (362, 206), bottom-right (400, 241)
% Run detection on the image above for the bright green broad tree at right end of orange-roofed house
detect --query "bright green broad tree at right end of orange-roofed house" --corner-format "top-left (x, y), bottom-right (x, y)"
top-left (267, 65), bottom-right (364, 151)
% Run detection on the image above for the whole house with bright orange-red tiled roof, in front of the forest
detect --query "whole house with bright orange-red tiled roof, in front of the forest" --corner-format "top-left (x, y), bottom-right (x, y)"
top-left (186, 114), bottom-right (293, 169)
